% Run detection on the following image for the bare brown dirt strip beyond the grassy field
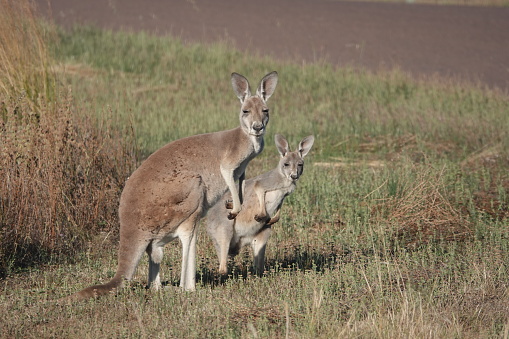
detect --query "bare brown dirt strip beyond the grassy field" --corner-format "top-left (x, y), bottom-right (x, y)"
top-left (35, 0), bottom-right (509, 91)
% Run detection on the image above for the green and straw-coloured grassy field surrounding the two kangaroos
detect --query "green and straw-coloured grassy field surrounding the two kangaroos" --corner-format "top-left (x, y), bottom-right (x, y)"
top-left (0, 2), bottom-right (509, 338)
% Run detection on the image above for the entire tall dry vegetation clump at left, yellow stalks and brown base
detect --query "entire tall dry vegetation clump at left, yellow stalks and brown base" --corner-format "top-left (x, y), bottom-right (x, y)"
top-left (0, 0), bottom-right (136, 278)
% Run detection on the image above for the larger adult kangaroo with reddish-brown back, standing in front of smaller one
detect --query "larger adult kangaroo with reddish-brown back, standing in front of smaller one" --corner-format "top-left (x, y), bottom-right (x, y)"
top-left (68, 72), bottom-right (278, 300)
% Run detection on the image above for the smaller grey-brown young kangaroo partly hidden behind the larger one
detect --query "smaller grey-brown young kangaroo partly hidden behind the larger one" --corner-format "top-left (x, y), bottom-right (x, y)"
top-left (207, 135), bottom-right (314, 274)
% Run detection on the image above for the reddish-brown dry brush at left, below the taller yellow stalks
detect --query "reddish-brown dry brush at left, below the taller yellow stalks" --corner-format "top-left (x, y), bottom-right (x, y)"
top-left (0, 94), bottom-right (136, 276)
